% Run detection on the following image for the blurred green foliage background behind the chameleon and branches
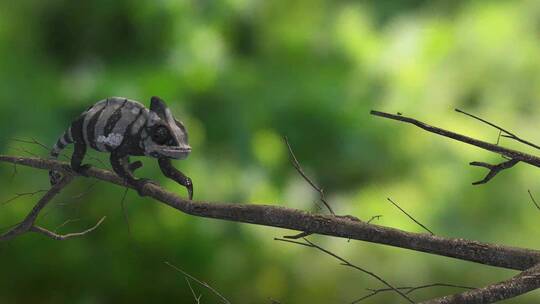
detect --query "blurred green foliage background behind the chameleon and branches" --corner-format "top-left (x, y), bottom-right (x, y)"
top-left (0, 0), bottom-right (540, 304)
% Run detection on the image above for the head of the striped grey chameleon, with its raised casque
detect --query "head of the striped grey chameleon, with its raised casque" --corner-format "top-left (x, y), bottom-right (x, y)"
top-left (141, 96), bottom-right (191, 159)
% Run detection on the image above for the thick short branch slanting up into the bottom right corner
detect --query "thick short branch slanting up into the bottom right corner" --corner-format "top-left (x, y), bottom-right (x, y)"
top-left (423, 265), bottom-right (540, 304)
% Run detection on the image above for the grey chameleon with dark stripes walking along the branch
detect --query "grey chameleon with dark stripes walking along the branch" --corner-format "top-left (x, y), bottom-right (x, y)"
top-left (49, 96), bottom-right (193, 200)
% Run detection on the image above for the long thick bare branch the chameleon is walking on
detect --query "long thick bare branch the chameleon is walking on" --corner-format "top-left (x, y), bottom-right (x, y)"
top-left (0, 156), bottom-right (540, 270)
